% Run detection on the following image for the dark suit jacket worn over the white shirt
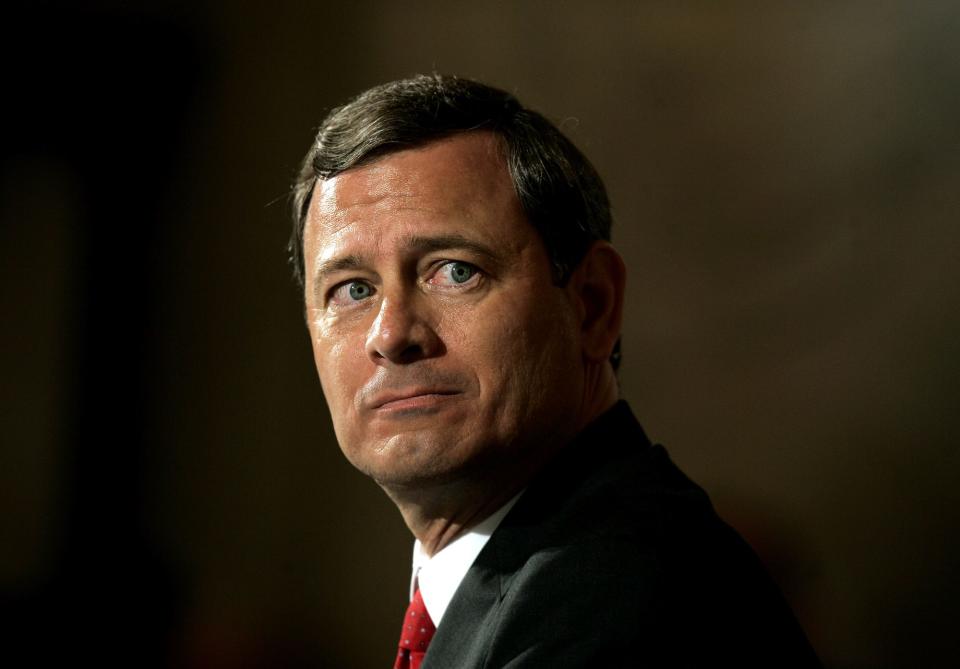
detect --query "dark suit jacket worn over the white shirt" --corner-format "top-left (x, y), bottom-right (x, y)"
top-left (423, 402), bottom-right (820, 669)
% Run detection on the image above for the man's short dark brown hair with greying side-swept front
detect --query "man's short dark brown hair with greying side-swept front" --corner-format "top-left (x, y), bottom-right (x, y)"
top-left (289, 74), bottom-right (619, 367)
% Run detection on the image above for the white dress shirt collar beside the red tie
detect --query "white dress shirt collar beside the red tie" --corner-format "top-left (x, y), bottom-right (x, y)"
top-left (410, 491), bottom-right (523, 627)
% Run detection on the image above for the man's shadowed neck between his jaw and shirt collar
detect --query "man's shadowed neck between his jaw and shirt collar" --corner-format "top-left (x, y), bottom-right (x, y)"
top-left (381, 364), bottom-right (619, 556)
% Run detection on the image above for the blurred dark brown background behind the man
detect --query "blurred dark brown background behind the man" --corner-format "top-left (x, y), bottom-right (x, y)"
top-left (0, 0), bottom-right (960, 669)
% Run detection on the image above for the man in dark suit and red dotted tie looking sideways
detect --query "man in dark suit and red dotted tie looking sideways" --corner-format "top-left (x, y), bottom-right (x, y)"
top-left (291, 76), bottom-right (817, 669)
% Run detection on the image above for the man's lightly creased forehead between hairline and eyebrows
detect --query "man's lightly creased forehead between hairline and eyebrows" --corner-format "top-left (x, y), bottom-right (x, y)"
top-left (304, 132), bottom-right (533, 253)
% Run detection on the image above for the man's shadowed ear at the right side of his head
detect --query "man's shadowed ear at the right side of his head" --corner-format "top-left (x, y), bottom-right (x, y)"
top-left (567, 240), bottom-right (627, 363)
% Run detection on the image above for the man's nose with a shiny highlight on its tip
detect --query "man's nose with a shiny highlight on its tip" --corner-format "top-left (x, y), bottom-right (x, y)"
top-left (366, 295), bottom-right (443, 365)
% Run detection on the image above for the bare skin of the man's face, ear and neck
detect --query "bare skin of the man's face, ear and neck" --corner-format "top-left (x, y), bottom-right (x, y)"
top-left (304, 132), bottom-right (625, 555)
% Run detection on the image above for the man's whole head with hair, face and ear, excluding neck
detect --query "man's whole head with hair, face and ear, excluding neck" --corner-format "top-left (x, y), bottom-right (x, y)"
top-left (291, 76), bottom-right (623, 500)
